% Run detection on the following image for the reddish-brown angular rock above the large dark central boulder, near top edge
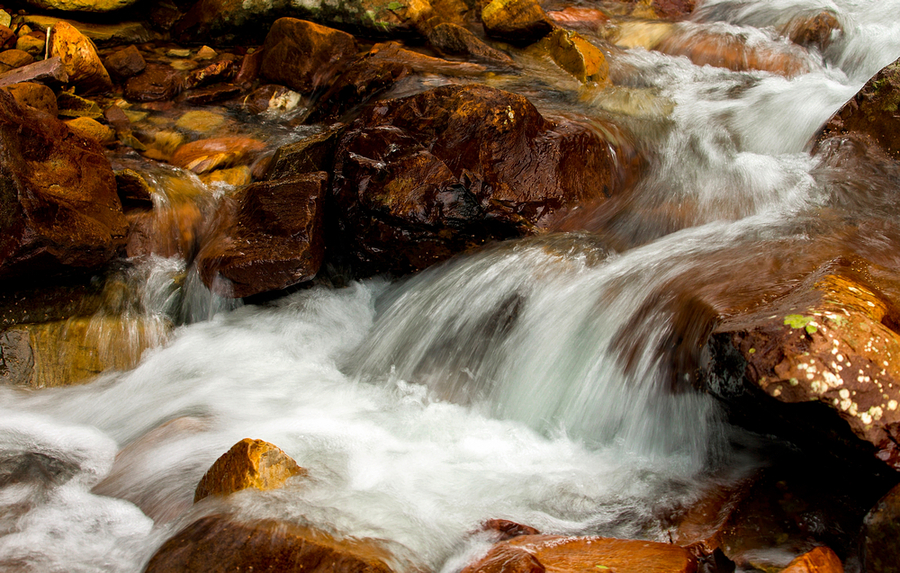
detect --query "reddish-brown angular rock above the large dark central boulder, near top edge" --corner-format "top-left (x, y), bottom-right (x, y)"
top-left (260, 18), bottom-right (358, 94)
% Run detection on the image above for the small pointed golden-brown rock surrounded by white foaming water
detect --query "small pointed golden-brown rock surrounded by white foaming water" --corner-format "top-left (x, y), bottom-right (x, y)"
top-left (194, 438), bottom-right (306, 503)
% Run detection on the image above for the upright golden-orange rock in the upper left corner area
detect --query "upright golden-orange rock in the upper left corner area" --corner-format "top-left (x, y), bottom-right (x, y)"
top-left (50, 20), bottom-right (112, 93)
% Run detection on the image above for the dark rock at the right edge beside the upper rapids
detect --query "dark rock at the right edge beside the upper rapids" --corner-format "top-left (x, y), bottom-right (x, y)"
top-left (817, 60), bottom-right (900, 159)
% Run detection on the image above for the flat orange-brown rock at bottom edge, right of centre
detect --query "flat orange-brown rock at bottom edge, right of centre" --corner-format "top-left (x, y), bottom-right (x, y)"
top-left (463, 535), bottom-right (697, 573)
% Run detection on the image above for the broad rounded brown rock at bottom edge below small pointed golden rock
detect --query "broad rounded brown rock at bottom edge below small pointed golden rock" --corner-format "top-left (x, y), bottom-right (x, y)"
top-left (144, 515), bottom-right (394, 573)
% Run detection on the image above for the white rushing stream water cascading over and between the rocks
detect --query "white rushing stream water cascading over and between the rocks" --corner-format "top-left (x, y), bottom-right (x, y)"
top-left (0, 0), bottom-right (900, 572)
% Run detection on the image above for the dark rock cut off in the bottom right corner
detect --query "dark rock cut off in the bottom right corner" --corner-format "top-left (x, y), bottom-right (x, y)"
top-left (860, 486), bottom-right (900, 573)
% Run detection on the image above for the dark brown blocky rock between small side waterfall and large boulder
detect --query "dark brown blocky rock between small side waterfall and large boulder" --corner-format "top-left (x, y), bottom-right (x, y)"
top-left (197, 172), bottom-right (328, 298)
